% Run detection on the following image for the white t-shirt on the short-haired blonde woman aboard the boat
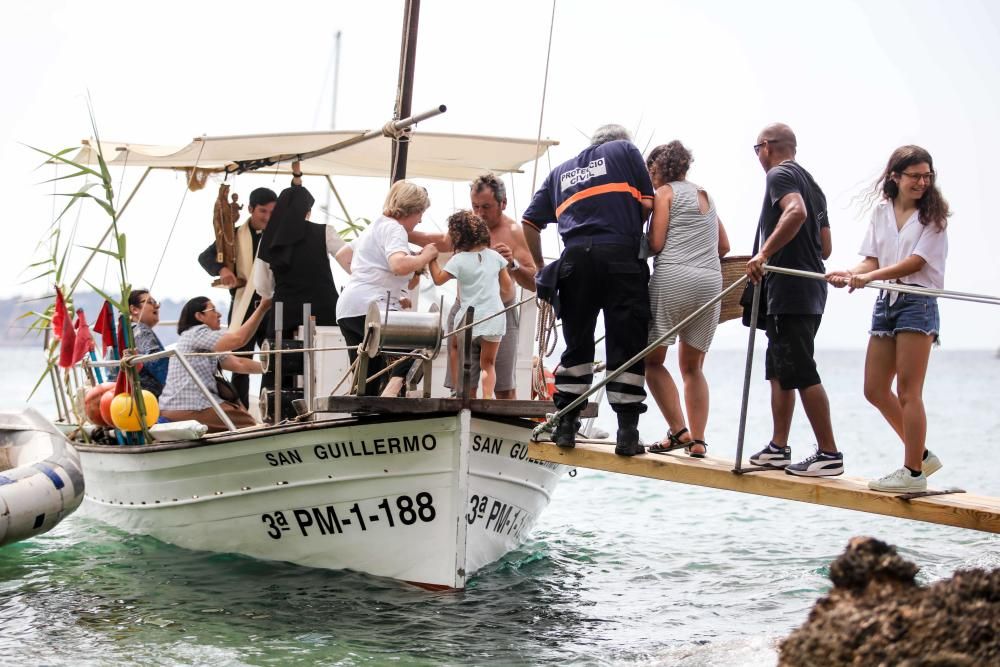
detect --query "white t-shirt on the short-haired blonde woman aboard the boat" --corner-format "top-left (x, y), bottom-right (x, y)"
top-left (337, 215), bottom-right (410, 320)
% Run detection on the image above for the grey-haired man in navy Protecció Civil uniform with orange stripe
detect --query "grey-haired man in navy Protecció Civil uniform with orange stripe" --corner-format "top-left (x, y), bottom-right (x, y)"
top-left (522, 125), bottom-right (653, 456)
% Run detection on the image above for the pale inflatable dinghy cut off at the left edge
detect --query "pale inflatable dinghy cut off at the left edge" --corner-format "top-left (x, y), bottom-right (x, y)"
top-left (0, 408), bottom-right (84, 546)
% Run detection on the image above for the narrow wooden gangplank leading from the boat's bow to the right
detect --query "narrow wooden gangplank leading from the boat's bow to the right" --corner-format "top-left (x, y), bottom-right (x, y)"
top-left (528, 442), bottom-right (1000, 533)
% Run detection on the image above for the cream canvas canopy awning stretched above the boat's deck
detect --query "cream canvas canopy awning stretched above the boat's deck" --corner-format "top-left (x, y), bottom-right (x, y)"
top-left (69, 131), bottom-right (559, 180)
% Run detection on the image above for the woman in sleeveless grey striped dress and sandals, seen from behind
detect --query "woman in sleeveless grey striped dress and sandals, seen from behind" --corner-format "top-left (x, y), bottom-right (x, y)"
top-left (646, 141), bottom-right (729, 458)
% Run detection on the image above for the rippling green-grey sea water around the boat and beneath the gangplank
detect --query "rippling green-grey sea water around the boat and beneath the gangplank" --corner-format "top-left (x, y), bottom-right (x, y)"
top-left (0, 350), bottom-right (1000, 667)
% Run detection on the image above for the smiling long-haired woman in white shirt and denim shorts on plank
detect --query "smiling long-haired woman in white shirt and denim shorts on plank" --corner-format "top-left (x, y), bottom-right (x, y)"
top-left (827, 146), bottom-right (950, 493)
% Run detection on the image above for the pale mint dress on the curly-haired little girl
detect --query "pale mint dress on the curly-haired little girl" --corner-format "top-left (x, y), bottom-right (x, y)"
top-left (444, 248), bottom-right (507, 337)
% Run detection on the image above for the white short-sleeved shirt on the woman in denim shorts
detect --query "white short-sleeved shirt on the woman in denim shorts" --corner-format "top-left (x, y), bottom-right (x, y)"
top-left (858, 199), bottom-right (948, 302)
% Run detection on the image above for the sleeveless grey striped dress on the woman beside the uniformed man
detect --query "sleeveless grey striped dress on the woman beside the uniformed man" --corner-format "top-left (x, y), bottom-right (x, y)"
top-left (649, 181), bottom-right (722, 352)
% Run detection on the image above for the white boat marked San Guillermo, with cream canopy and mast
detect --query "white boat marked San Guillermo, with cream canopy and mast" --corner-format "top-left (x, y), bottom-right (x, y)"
top-left (33, 0), bottom-right (593, 588)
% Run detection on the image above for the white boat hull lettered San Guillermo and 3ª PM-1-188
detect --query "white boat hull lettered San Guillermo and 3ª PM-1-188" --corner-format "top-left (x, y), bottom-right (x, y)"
top-left (80, 410), bottom-right (567, 588)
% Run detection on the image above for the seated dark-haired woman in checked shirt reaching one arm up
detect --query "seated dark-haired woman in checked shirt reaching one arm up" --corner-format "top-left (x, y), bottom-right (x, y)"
top-left (160, 296), bottom-right (271, 433)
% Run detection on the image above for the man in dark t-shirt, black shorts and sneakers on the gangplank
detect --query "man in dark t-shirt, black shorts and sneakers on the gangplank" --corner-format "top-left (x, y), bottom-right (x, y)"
top-left (747, 123), bottom-right (844, 477)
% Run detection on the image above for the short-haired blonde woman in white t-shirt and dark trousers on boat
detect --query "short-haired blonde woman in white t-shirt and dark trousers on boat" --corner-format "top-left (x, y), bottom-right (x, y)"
top-left (337, 181), bottom-right (437, 396)
